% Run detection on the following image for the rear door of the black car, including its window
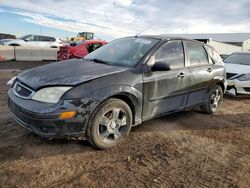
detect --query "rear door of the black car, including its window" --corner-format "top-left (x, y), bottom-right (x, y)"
top-left (184, 41), bottom-right (214, 106)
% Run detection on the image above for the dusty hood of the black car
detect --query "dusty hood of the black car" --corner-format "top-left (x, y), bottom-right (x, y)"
top-left (17, 59), bottom-right (128, 90)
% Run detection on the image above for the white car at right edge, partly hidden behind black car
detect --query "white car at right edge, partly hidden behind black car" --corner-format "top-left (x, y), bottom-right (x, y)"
top-left (224, 52), bottom-right (250, 96)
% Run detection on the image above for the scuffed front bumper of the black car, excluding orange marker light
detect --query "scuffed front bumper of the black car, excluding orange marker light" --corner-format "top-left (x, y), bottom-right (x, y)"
top-left (8, 89), bottom-right (99, 138)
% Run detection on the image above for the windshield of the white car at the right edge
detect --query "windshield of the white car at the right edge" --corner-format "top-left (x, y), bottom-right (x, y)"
top-left (224, 53), bottom-right (250, 65)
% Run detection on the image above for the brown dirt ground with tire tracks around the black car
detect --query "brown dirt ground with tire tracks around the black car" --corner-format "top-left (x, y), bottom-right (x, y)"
top-left (0, 63), bottom-right (250, 187)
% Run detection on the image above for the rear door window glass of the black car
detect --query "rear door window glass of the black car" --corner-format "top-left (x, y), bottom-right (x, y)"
top-left (187, 42), bottom-right (209, 66)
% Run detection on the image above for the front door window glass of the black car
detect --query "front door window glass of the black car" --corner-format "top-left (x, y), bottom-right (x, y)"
top-left (155, 41), bottom-right (184, 68)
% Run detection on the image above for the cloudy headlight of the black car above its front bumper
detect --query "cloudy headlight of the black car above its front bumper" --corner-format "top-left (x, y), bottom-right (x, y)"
top-left (32, 87), bottom-right (71, 103)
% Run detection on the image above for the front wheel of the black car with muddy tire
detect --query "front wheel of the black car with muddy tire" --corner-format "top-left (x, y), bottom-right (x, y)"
top-left (86, 99), bottom-right (132, 149)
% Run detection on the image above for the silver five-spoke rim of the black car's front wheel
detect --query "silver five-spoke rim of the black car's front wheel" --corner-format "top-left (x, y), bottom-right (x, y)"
top-left (99, 108), bottom-right (127, 143)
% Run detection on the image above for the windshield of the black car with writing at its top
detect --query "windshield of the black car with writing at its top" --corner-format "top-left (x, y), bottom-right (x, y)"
top-left (84, 37), bottom-right (159, 68)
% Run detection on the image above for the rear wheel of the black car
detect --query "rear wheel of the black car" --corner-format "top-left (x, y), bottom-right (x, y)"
top-left (200, 85), bottom-right (223, 114)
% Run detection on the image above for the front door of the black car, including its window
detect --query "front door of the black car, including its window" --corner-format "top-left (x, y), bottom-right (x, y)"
top-left (143, 40), bottom-right (190, 120)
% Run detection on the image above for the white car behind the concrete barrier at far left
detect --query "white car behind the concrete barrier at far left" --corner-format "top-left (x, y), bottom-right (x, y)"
top-left (3, 35), bottom-right (64, 48)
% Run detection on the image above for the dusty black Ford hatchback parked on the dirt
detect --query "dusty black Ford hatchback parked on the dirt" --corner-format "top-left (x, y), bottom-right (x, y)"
top-left (8, 35), bottom-right (225, 149)
